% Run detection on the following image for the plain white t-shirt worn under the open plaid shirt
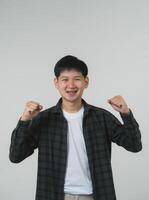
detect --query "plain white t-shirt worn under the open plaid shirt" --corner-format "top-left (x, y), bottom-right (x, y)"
top-left (63, 107), bottom-right (92, 194)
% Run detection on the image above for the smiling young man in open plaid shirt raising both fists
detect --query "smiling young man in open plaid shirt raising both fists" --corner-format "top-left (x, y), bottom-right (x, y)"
top-left (10, 56), bottom-right (142, 200)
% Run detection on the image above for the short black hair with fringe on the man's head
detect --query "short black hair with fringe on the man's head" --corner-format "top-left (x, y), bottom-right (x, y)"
top-left (54, 55), bottom-right (88, 78)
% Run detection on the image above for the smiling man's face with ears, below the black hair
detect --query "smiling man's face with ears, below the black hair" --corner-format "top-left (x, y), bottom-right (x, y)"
top-left (54, 69), bottom-right (89, 102)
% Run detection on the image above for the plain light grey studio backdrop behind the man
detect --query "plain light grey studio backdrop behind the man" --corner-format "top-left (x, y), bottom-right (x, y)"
top-left (0, 0), bottom-right (149, 200)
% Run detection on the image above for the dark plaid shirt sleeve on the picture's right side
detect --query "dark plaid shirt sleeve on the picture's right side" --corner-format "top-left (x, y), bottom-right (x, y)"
top-left (106, 109), bottom-right (142, 152)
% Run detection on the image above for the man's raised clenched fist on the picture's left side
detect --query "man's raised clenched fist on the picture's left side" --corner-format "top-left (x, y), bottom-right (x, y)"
top-left (20, 101), bottom-right (43, 121)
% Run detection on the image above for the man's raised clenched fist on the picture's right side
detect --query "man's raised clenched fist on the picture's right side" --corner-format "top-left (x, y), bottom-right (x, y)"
top-left (107, 95), bottom-right (130, 114)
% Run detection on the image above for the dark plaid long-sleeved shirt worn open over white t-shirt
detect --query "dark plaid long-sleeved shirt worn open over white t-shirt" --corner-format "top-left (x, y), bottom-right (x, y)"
top-left (9, 99), bottom-right (142, 200)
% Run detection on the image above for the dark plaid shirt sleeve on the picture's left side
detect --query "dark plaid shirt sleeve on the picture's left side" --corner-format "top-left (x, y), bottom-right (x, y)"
top-left (9, 117), bottom-right (40, 163)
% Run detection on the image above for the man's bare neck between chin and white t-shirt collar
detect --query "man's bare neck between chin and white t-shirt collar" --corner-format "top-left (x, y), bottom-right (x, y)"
top-left (62, 99), bottom-right (82, 113)
